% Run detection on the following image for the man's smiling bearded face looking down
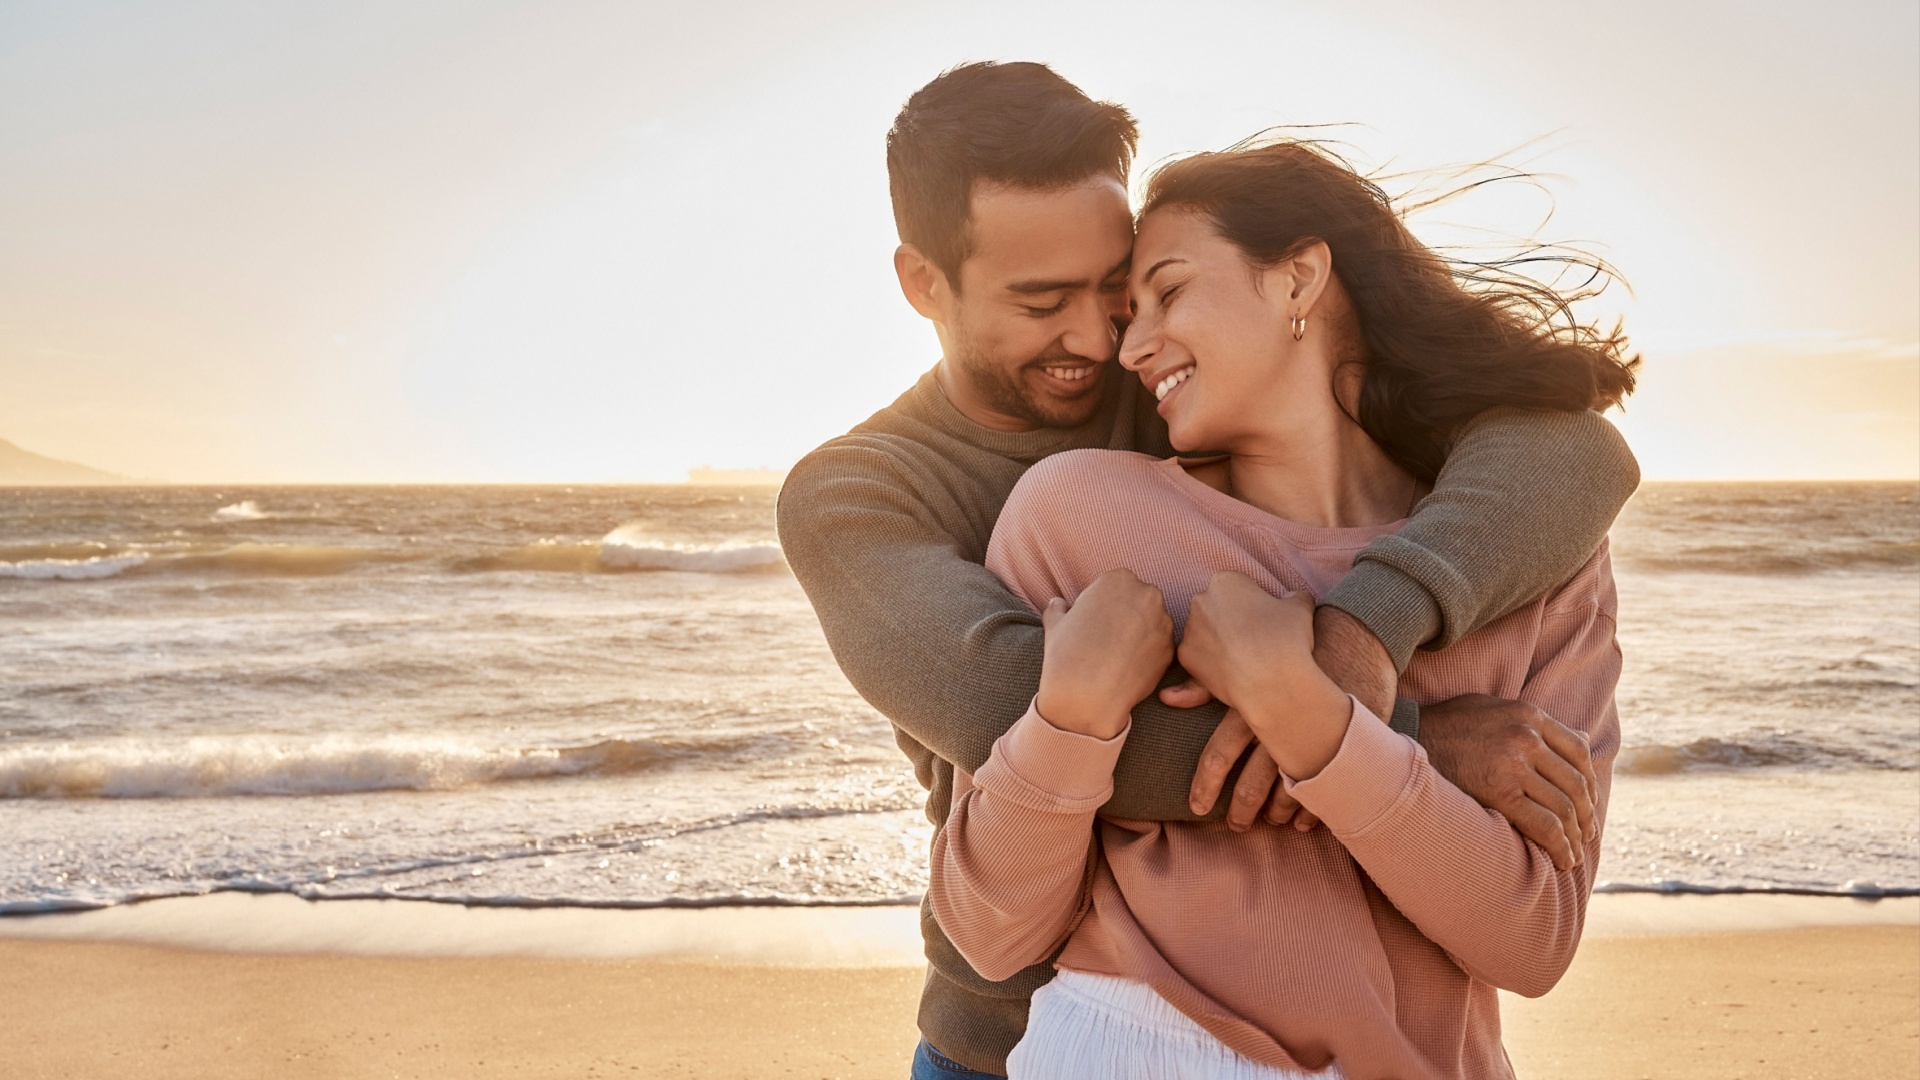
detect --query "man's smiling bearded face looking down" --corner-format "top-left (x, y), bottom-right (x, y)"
top-left (939, 179), bottom-right (1133, 430)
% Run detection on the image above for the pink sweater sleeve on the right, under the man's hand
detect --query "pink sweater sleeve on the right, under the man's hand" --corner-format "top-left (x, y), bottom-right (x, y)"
top-left (1288, 555), bottom-right (1620, 997)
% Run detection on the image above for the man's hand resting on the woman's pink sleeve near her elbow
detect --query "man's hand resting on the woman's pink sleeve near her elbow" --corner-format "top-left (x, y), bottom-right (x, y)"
top-left (1421, 694), bottom-right (1599, 871)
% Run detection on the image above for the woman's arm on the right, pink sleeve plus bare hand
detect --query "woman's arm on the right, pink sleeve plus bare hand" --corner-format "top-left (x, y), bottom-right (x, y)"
top-left (1181, 552), bottom-right (1620, 995)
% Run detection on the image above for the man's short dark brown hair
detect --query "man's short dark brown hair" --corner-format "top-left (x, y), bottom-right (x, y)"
top-left (887, 61), bottom-right (1140, 288)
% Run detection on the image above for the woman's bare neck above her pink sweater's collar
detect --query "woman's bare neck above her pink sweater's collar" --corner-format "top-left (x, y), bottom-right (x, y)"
top-left (1221, 401), bottom-right (1423, 528)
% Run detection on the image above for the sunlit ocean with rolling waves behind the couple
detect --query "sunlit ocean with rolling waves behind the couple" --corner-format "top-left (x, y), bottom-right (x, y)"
top-left (0, 484), bottom-right (1920, 913)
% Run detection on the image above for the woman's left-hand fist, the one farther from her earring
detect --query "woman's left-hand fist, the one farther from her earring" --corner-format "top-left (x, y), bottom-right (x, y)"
top-left (1033, 569), bottom-right (1173, 738)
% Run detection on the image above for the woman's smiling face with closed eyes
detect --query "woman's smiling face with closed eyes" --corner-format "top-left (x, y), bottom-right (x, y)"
top-left (1119, 209), bottom-right (1331, 454)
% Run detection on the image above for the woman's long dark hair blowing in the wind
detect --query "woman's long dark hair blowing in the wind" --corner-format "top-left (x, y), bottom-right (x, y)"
top-left (1140, 138), bottom-right (1640, 480)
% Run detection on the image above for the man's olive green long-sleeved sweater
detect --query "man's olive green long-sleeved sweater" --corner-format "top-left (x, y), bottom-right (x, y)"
top-left (780, 365), bottom-right (1640, 1072)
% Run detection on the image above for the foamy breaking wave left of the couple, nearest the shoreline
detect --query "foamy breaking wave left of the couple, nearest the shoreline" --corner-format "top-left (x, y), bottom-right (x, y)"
top-left (0, 736), bottom-right (753, 799)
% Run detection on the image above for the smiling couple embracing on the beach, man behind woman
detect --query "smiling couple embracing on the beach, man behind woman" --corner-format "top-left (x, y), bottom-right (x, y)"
top-left (780, 63), bottom-right (1638, 1080)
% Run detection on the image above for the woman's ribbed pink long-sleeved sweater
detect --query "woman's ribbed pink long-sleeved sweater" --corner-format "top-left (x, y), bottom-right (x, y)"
top-left (929, 450), bottom-right (1620, 1080)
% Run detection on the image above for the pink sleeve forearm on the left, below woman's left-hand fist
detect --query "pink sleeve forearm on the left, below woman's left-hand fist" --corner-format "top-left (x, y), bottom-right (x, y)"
top-left (927, 709), bottom-right (1127, 982)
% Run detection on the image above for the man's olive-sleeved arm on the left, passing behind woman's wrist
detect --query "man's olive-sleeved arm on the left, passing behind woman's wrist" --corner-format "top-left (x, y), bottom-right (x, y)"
top-left (780, 444), bottom-right (1223, 821)
